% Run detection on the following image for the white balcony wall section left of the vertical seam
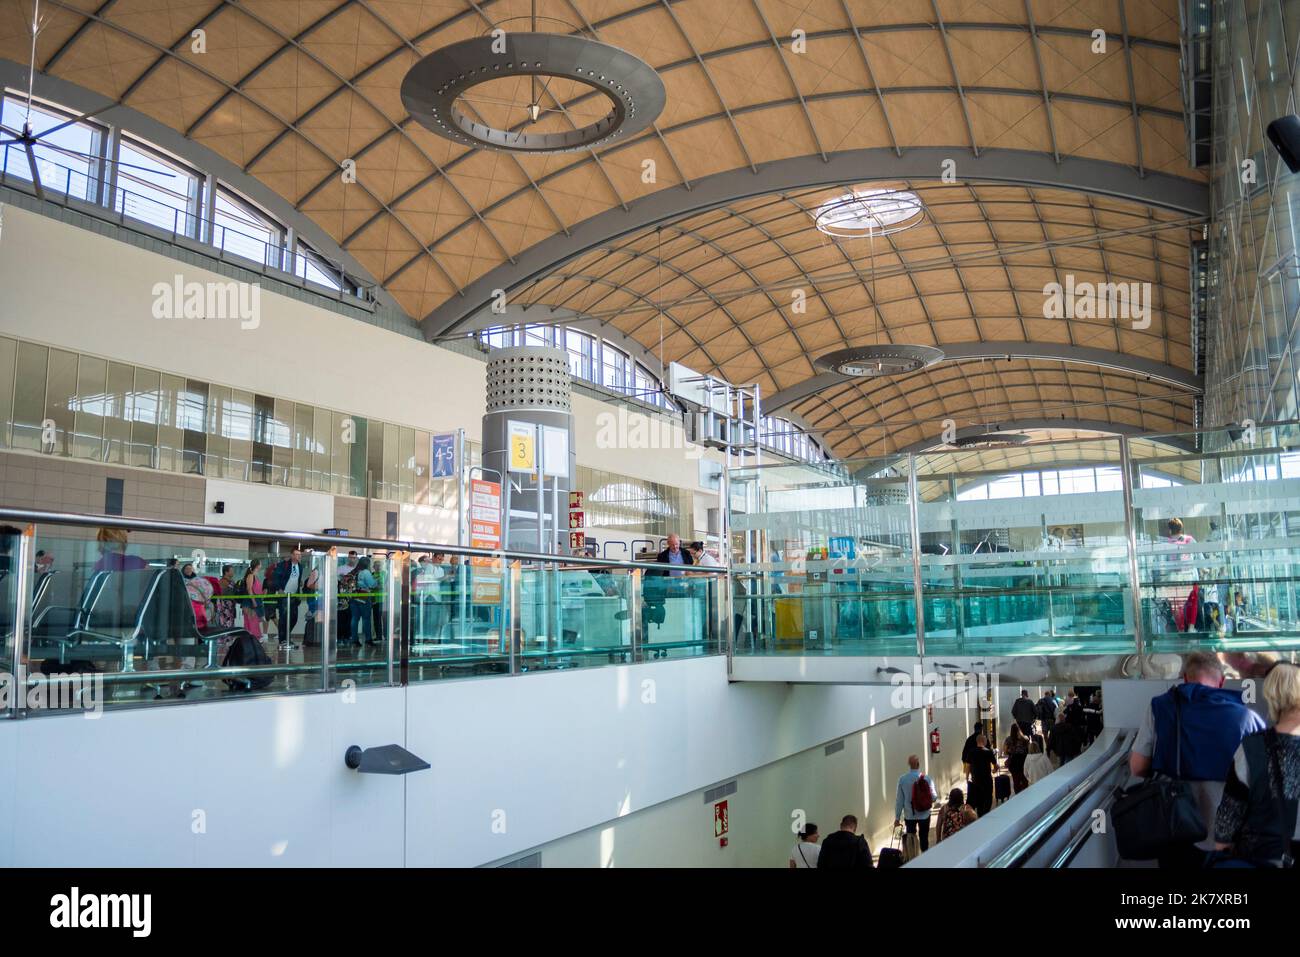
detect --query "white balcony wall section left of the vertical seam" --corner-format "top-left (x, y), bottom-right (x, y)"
top-left (0, 688), bottom-right (403, 867)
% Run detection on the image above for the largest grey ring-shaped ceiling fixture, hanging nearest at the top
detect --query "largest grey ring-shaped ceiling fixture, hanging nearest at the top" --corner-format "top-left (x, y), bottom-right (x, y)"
top-left (402, 28), bottom-right (666, 153)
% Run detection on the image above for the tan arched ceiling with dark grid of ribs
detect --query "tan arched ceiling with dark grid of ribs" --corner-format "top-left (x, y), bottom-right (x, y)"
top-left (0, 0), bottom-right (1204, 455)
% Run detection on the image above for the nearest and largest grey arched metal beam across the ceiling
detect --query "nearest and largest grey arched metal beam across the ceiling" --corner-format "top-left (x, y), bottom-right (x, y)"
top-left (421, 147), bottom-right (1209, 338)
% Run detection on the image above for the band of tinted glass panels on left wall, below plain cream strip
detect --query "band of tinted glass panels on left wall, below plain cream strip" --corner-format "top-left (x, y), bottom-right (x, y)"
top-left (0, 337), bottom-right (431, 507)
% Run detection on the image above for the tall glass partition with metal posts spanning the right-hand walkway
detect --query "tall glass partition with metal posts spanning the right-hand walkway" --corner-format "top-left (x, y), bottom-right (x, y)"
top-left (729, 423), bottom-right (1300, 657)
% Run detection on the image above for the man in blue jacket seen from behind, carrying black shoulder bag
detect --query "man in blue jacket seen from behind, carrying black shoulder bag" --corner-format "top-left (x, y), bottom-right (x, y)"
top-left (1128, 651), bottom-right (1264, 869)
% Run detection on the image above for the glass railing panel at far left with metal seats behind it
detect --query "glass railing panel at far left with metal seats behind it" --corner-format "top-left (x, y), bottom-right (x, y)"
top-left (26, 528), bottom-right (335, 710)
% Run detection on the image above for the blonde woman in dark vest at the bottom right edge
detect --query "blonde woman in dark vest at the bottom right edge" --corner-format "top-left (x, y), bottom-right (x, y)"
top-left (1214, 662), bottom-right (1300, 867)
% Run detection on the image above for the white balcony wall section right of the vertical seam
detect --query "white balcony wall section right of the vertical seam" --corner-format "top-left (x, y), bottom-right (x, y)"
top-left (407, 658), bottom-right (966, 866)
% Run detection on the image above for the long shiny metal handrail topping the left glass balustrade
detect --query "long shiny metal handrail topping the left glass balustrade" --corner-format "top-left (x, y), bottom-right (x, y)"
top-left (0, 507), bottom-right (727, 575)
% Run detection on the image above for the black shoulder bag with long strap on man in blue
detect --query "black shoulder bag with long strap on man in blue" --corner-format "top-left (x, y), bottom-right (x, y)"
top-left (1110, 690), bottom-right (1205, 861)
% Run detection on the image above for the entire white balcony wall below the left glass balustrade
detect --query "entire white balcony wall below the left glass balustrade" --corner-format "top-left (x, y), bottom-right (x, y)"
top-left (0, 657), bottom-right (966, 866)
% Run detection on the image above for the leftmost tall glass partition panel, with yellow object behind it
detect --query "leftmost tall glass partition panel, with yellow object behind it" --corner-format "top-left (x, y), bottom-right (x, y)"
top-left (731, 456), bottom-right (917, 655)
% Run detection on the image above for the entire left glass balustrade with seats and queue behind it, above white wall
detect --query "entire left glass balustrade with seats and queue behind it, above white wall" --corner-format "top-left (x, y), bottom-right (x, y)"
top-left (0, 510), bottom-right (727, 710)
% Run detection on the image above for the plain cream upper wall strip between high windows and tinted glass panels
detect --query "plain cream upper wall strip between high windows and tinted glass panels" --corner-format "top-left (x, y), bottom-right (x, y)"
top-left (0, 205), bottom-right (717, 488)
